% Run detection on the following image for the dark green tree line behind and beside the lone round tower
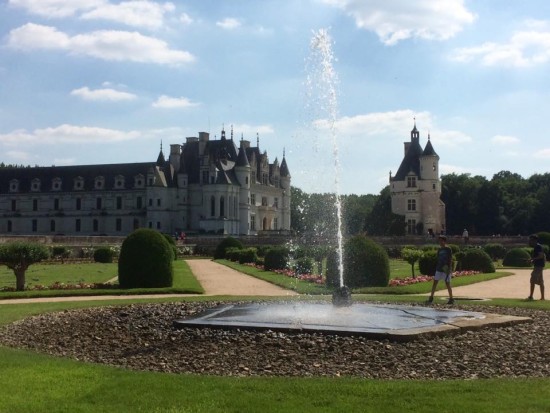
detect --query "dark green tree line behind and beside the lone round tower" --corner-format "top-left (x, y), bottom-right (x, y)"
top-left (291, 171), bottom-right (550, 238)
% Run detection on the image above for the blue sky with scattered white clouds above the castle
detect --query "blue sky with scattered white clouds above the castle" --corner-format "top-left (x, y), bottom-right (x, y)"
top-left (0, 0), bottom-right (550, 194)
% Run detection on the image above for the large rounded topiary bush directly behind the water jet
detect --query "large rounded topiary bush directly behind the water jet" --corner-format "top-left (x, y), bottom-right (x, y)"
top-left (327, 235), bottom-right (390, 288)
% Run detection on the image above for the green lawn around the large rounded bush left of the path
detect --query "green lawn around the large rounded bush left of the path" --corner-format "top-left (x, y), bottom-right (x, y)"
top-left (0, 260), bottom-right (204, 299)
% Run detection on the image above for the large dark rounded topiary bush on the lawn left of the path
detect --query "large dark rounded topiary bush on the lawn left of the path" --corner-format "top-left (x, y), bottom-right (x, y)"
top-left (118, 228), bottom-right (174, 288)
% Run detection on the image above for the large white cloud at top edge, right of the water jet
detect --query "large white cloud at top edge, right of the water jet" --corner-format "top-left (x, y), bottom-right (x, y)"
top-left (323, 0), bottom-right (476, 45)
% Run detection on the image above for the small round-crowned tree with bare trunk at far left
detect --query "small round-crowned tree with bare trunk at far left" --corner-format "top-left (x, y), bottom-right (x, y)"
top-left (0, 242), bottom-right (50, 291)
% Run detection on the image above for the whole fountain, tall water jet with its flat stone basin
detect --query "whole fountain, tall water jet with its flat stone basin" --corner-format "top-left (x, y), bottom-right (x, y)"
top-left (174, 30), bottom-right (524, 341)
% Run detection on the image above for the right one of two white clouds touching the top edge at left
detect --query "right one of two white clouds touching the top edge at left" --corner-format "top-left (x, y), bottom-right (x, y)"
top-left (81, 0), bottom-right (175, 29)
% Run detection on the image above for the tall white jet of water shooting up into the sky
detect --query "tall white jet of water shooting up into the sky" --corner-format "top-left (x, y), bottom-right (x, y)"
top-left (306, 29), bottom-right (344, 287)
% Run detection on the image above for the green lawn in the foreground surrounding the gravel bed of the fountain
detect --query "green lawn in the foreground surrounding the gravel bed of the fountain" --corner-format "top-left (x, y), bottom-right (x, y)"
top-left (0, 296), bottom-right (550, 413)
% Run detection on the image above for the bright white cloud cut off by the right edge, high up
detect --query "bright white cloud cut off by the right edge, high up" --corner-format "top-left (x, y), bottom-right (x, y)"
top-left (451, 20), bottom-right (550, 67)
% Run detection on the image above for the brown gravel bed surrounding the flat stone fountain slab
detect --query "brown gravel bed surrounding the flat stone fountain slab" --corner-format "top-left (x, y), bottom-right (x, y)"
top-left (0, 302), bottom-right (550, 379)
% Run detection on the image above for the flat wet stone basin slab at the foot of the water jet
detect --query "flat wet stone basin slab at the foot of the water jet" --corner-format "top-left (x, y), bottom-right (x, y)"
top-left (173, 302), bottom-right (530, 341)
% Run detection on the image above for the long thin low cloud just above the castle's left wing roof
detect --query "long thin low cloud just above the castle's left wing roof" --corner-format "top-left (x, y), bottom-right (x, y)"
top-left (0, 124), bottom-right (141, 146)
